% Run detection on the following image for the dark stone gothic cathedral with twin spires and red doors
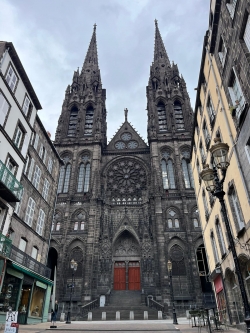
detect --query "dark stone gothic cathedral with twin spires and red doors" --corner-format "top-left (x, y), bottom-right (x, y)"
top-left (49, 22), bottom-right (203, 311)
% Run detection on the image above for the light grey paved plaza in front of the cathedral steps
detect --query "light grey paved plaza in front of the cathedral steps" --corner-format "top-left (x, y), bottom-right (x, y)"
top-left (0, 318), bottom-right (246, 333)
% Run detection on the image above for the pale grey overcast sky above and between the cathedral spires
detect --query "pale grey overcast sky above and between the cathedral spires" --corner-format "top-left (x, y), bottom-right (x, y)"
top-left (0, 0), bottom-right (210, 139)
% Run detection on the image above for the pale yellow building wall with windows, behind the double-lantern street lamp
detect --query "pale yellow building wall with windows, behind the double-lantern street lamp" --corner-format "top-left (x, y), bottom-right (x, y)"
top-left (192, 24), bottom-right (250, 322)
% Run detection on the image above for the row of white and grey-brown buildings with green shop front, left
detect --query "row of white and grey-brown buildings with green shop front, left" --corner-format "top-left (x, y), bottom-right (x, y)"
top-left (0, 43), bottom-right (62, 324)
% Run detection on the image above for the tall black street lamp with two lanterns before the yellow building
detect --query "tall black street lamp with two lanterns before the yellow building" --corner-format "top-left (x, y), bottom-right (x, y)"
top-left (200, 137), bottom-right (250, 333)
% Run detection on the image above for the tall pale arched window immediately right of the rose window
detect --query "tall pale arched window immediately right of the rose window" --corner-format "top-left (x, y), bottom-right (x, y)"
top-left (161, 151), bottom-right (176, 190)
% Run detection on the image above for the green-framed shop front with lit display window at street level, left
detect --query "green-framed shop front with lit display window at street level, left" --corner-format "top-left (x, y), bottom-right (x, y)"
top-left (0, 262), bottom-right (53, 324)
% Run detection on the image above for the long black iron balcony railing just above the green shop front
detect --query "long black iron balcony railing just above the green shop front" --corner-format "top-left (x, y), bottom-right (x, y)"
top-left (8, 245), bottom-right (51, 279)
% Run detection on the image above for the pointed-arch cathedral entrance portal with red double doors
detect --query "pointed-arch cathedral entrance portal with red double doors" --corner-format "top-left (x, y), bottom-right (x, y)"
top-left (113, 230), bottom-right (141, 290)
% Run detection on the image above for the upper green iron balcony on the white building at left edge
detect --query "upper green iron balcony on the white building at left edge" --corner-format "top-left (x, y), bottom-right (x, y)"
top-left (0, 160), bottom-right (23, 202)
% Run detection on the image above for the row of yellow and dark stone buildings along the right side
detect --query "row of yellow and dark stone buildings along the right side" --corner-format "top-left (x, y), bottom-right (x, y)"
top-left (192, 1), bottom-right (250, 323)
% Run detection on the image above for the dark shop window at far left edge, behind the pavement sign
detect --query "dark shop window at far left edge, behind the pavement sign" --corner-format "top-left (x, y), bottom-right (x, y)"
top-left (0, 273), bottom-right (22, 312)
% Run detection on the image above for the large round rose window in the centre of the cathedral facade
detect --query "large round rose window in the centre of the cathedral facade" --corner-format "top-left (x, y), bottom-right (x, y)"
top-left (107, 159), bottom-right (146, 200)
